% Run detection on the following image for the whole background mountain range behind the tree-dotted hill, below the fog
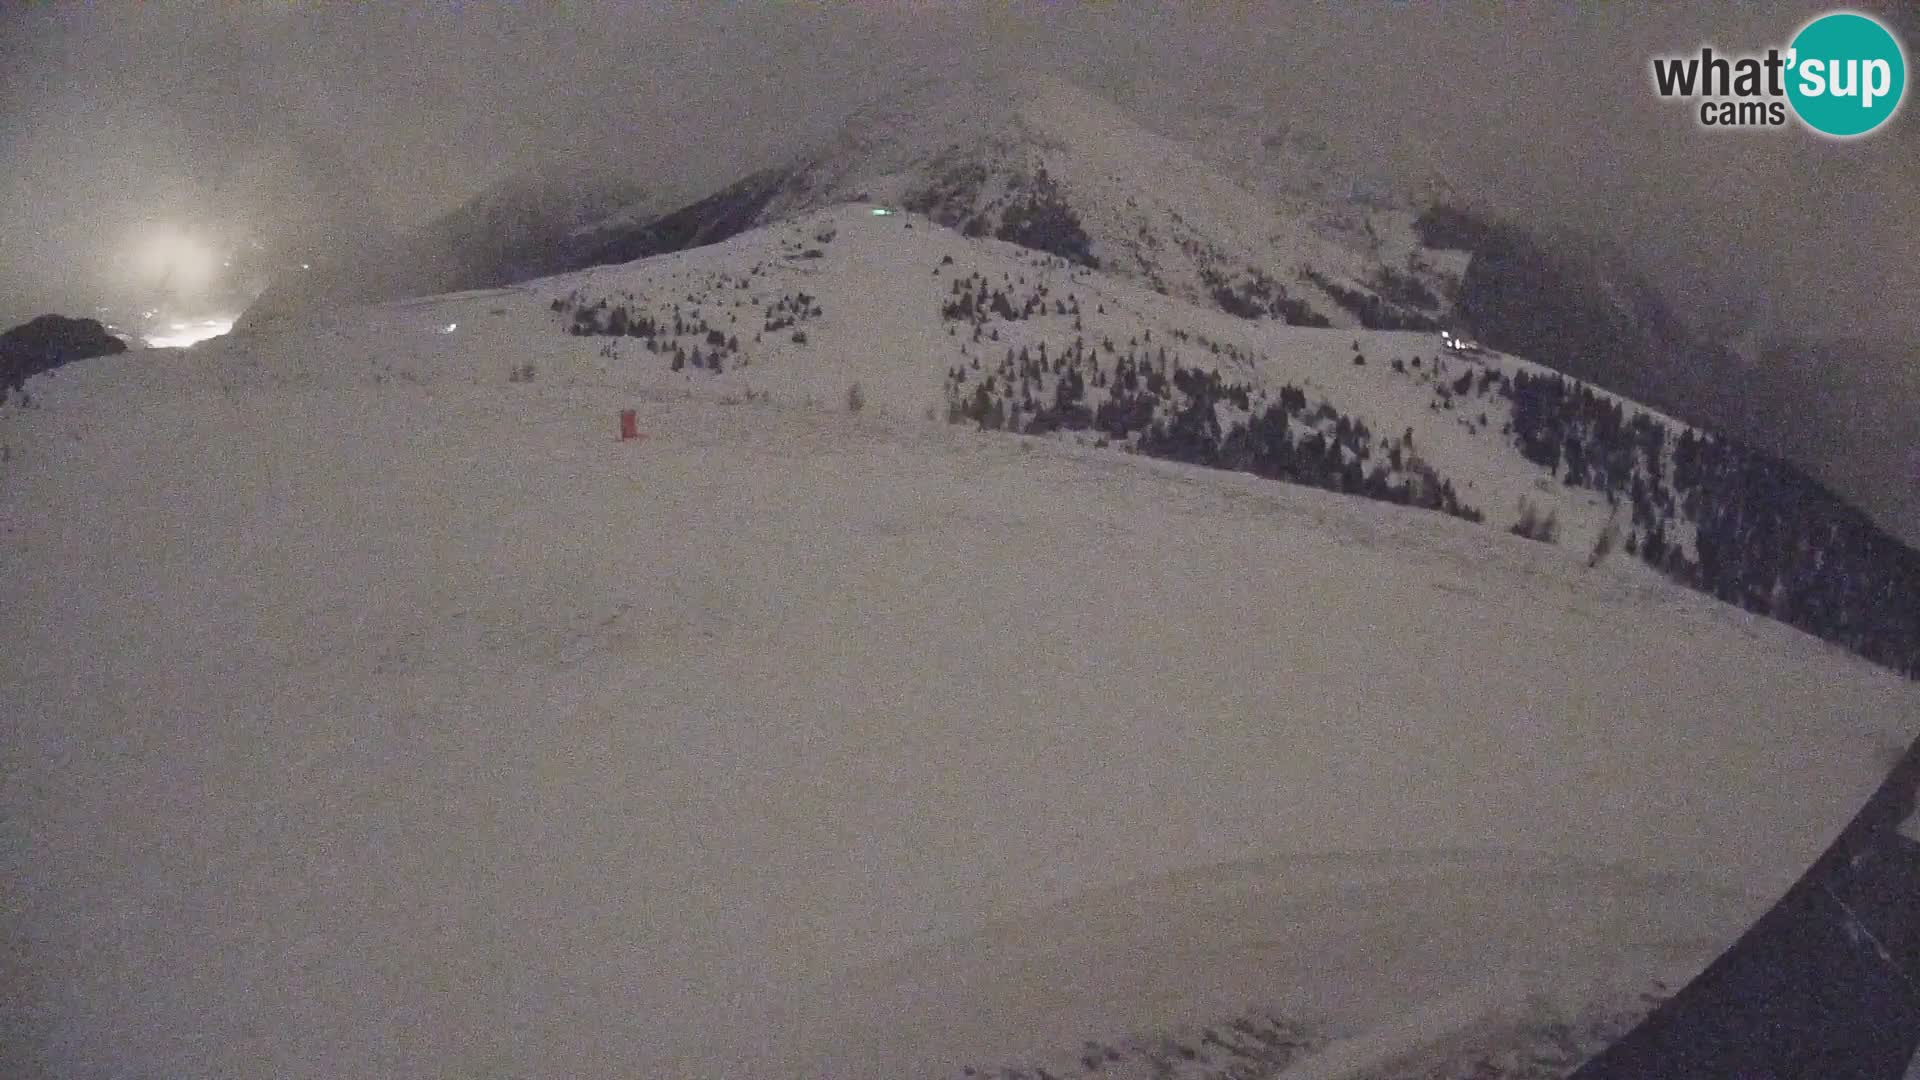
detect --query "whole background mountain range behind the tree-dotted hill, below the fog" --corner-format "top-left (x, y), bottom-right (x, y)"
top-left (242, 75), bottom-right (1910, 564)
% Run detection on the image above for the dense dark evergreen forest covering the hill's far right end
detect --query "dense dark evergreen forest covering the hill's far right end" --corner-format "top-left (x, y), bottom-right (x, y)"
top-left (1503, 373), bottom-right (1920, 676)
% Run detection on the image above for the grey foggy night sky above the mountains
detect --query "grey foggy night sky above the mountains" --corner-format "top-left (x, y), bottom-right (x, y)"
top-left (0, 2), bottom-right (1920, 536)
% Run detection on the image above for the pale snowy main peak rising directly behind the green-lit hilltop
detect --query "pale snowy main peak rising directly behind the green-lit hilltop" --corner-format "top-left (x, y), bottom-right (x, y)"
top-left (637, 77), bottom-right (1465, 327)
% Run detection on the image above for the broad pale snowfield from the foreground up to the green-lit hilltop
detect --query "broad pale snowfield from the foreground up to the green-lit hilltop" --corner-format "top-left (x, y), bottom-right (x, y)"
top-left (0, 206), bottom-right (1920, 1078)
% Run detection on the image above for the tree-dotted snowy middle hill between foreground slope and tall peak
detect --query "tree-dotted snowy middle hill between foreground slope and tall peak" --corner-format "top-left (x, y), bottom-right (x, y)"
top-left (529, 206), bottom-right (1920, 671)
